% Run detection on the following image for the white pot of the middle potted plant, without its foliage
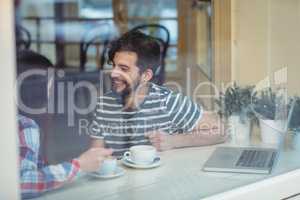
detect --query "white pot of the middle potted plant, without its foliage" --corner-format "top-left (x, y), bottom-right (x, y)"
top-left (259, 119), bottom-right (285, 146)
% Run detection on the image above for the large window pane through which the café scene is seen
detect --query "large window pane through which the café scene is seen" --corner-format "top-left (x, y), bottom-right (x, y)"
top-left (15, 0), bottom-right (300, 200)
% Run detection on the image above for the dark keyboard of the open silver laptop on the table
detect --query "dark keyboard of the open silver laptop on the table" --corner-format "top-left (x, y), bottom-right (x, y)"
top-left (236, 150), bottom-right (275, 168)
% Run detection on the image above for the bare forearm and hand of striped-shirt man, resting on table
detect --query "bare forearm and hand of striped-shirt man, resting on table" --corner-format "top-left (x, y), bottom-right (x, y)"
top-left (147, 113), bottom-right (227, 151)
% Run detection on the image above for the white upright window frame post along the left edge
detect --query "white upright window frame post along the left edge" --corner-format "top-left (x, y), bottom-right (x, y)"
top-left (0, 0), bottom-right (20, 200)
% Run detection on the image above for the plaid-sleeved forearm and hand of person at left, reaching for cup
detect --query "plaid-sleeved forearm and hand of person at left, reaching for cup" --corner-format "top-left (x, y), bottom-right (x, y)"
top-left (21, 148), bottom-right (112, 198)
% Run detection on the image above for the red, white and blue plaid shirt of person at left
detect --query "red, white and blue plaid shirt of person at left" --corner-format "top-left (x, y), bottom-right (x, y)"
top-left (19, 117), bottom-right (80, 199)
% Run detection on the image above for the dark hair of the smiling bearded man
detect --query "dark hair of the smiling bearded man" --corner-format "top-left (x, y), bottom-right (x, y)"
top-left (108, 31), bottom-right (161, 74)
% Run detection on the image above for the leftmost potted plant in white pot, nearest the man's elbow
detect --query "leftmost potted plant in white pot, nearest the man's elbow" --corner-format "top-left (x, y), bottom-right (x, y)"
top-left (216, 83), bottom-right (254, 145)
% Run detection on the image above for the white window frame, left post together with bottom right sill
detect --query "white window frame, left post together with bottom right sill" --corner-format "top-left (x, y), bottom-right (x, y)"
top-left (0, 0), bottom-right (300, 200)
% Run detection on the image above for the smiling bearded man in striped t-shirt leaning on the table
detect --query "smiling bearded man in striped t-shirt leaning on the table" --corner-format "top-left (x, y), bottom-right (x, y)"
top-left (90, 31), bottom-right (226, 156)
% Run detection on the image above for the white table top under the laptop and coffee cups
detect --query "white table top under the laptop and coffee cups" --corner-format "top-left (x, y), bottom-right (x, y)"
top-left (37, 133), bottom-right (300, 200)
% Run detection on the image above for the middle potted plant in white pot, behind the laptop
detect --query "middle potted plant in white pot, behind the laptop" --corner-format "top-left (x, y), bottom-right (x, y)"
top-left (253, 88), bottom-right (287, 146)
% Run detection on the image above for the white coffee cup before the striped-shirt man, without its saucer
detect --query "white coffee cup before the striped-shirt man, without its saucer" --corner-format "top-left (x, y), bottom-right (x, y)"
top-left (124, 145), bottom-right (157, 164)
